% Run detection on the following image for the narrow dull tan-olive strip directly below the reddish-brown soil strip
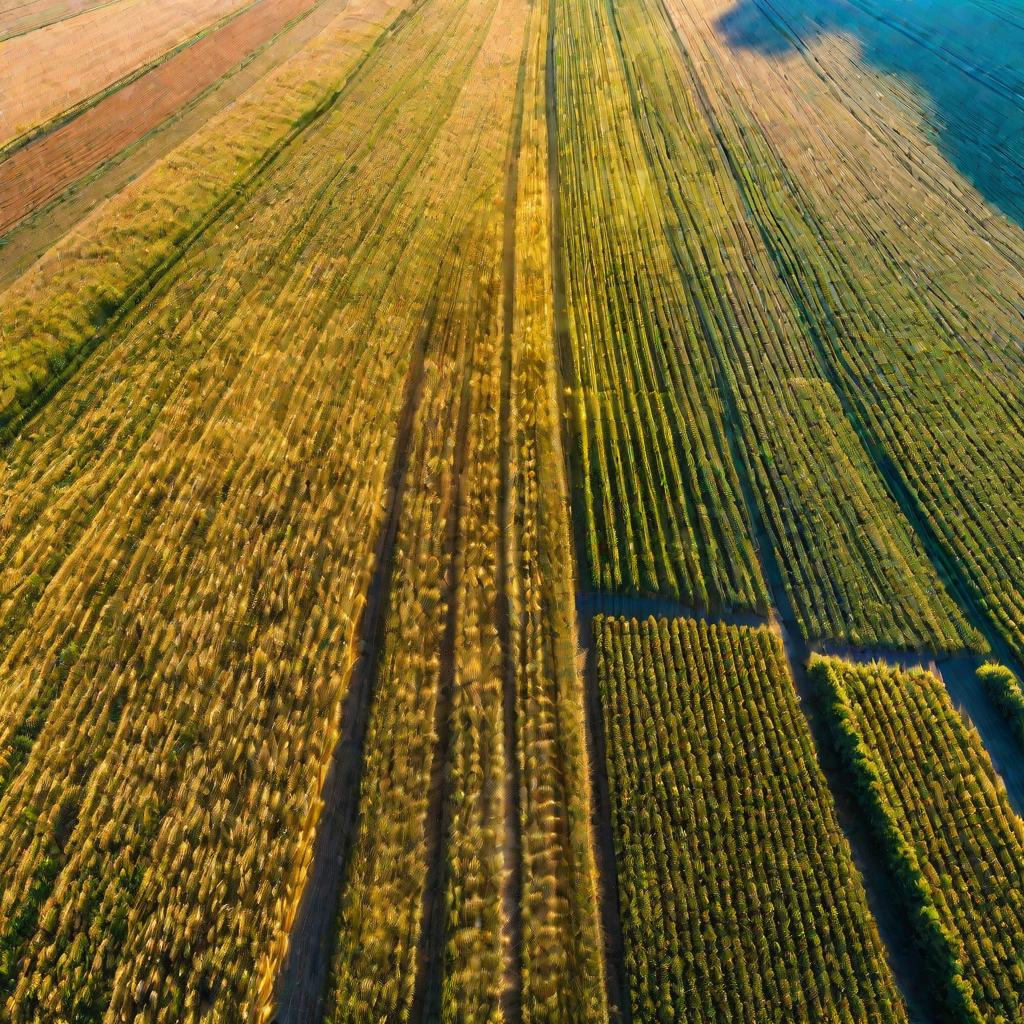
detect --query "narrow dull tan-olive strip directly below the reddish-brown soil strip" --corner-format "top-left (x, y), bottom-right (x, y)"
top-left (0, 0), bottom-right (366, 288)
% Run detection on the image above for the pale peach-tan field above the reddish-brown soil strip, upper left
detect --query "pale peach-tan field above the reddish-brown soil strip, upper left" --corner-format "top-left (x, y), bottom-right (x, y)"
top-left (0, 0), bottom-right (251, 145)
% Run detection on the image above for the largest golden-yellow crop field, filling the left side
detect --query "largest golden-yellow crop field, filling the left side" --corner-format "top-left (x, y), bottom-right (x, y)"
top-left (0, 5), bottom-right (507, 1022)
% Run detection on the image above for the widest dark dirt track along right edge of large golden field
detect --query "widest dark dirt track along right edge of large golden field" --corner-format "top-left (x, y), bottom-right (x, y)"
top-left (272, 303), bottom-right (433, 1024)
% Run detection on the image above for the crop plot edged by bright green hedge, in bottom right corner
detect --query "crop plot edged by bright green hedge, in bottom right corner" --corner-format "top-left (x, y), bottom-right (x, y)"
top-left (811, 658), bottom-right (1024, 1024)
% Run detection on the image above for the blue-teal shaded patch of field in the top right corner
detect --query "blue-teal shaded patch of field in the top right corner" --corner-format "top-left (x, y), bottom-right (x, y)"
top-left (716, 0), bottom-right (1024, 226)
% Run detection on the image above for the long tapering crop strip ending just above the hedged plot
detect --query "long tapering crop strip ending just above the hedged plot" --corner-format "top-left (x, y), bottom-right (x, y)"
top-left (581, 0), bottom-right (977, 648)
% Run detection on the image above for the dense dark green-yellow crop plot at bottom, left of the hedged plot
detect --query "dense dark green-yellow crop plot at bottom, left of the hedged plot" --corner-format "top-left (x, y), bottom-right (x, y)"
top-left (595, 616), bottom-right (906, 1024)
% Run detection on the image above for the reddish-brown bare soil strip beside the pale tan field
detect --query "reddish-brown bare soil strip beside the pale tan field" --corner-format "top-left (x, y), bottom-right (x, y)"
top-left (0, 0), bottom-right (316, 234)
